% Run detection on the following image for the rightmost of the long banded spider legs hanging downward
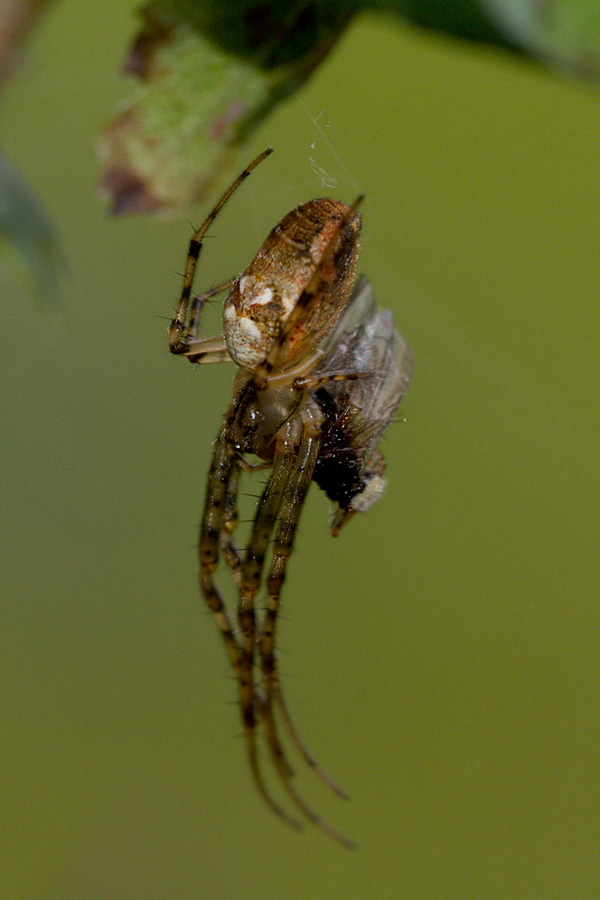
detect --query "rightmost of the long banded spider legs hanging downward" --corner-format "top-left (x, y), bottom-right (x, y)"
top-left (260, 432), bottom-right (355, 849)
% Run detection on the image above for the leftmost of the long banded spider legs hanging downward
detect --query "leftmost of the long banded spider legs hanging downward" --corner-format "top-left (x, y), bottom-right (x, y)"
top-left (198, 408), bottom-right (302, 829)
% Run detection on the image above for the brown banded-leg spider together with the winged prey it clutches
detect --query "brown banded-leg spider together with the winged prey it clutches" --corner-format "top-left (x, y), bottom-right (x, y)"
top-left (168, 149), bottom-right (412, 848)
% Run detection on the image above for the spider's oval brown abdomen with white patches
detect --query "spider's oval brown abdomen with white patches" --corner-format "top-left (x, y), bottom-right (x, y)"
top-left (223, 199), bottom-right (361, 371)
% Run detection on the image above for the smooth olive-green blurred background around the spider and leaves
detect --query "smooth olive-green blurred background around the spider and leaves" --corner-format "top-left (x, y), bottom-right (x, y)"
top-left (0, 0), bottom-right (600, 900)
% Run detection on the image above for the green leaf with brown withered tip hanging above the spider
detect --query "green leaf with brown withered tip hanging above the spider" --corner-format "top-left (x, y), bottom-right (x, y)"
top-left (100, 0), bottom-right (349, 212)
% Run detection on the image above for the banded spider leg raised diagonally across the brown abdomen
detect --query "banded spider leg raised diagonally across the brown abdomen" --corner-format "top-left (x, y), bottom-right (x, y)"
top-left (254, 194), bottom-right (364, 390)
